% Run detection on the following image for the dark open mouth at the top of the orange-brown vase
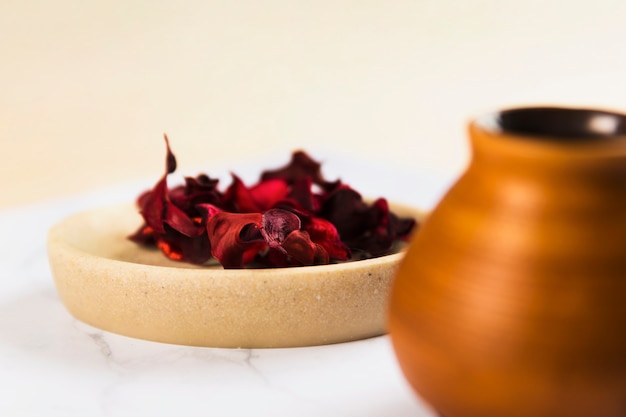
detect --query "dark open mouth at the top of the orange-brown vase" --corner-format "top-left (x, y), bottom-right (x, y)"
top-left (478, 107), bottom-right (626, 141)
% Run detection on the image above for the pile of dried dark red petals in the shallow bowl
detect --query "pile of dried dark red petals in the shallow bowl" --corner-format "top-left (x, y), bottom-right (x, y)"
top-left (129, 136), bottom-right (416, 268)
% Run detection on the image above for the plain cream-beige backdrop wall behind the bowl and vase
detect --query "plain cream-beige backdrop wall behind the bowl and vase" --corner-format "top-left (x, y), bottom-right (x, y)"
top-left (0, 0), bottom-right (626, 207)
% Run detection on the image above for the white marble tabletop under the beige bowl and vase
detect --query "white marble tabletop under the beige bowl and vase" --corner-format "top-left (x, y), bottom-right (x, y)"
top-left (0, 157), bottom-right (449, 417)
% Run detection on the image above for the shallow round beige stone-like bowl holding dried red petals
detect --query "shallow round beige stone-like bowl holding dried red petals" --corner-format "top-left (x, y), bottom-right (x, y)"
top-left (48, 204), bottom-right (419, 348)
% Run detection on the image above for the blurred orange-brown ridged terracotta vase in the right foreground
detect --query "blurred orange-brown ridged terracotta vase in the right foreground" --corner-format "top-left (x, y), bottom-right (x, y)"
top-left (389, 108), bottom-right (626, 417)
